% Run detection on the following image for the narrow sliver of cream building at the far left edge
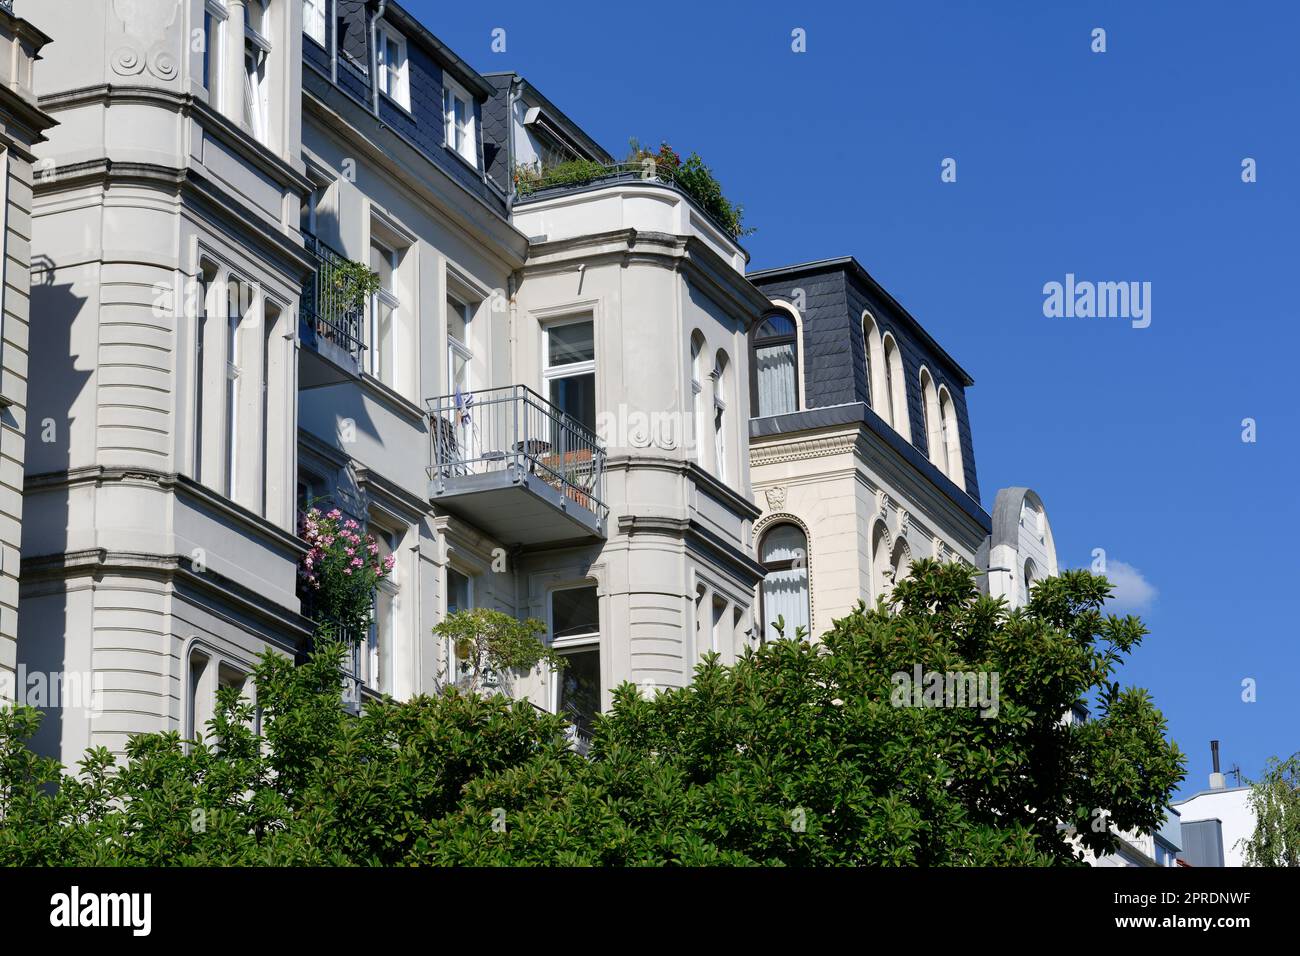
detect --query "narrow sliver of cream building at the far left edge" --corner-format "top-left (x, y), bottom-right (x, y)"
top-left (0, 4), bottom-right (60, 701)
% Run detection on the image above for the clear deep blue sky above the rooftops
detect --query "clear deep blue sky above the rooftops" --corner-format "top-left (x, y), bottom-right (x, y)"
top-left (406, 0), bottom-right (1300, 795)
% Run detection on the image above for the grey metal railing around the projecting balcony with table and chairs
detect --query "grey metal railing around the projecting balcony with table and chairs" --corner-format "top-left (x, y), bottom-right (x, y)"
top-left (426, 385), bottom-right (607, 520)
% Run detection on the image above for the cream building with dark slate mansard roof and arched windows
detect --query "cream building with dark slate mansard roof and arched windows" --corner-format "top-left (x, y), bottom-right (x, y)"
top-left (749, 258), bottom-right (1057, 637)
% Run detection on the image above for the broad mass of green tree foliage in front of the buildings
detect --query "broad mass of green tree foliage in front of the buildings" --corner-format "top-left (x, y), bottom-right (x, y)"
top-left (0, 561), bottom-right (1183, 866)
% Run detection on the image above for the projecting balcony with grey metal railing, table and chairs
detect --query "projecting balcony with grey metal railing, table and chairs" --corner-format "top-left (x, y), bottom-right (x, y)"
top-left (428, 385), bottom-right (608, 548)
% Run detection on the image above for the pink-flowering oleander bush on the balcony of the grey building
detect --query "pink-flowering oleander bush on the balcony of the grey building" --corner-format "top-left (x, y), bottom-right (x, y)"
top-left (298, 507), bottom-right (394, 640)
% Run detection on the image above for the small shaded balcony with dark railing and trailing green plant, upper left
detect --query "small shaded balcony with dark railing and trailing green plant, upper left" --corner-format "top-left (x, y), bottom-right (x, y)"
top-left (298, 233), bottom-right (365, 389)
